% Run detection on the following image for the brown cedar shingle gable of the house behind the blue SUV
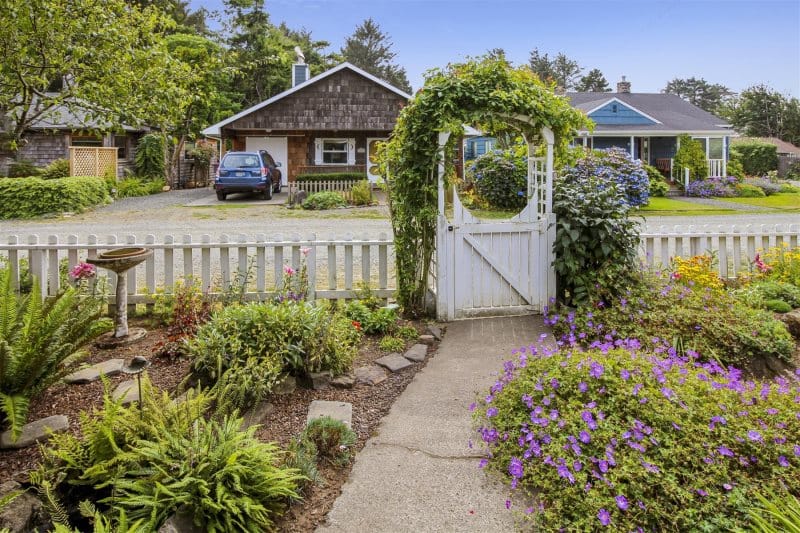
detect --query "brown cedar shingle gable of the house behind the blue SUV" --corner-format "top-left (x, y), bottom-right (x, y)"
top-left (230, 69), bottom-right (406, 132)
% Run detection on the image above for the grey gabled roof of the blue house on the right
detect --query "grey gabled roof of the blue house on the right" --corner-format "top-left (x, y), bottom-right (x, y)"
top-left (567, 93), bottom-right (732, 136)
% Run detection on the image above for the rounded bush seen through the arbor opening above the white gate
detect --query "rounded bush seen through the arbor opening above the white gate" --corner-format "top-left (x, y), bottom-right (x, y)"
top-left (466, 150), bottom-right (528, 209)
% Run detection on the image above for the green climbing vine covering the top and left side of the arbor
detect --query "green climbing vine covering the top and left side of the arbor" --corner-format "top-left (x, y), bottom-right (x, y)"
top-left (383, 57), bottom-right (589, 315)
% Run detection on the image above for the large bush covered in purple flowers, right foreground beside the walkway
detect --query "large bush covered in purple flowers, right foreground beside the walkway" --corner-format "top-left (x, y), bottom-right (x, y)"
top-left (471, 340), bottom-right (800, 532)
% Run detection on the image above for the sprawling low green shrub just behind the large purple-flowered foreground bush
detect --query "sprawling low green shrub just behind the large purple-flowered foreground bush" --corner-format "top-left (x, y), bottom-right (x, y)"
top-left (549, 270), bottom-right (794, 367)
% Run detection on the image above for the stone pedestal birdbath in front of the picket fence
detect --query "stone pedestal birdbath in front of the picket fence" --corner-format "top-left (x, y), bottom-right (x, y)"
top-left (86, 248), bottom-right (153, 348)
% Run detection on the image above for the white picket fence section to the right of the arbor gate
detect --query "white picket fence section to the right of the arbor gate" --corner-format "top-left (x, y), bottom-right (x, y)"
top-left (639, 224), bottom-right (800, 278)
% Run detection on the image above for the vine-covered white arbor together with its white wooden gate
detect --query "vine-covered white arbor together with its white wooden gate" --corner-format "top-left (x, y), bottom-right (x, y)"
top-left (384, 57), bottom-right (587, 319)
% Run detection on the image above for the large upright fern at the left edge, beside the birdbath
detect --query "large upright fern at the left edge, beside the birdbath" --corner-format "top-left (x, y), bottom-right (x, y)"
top-left (0, 269), bottom-right (111, 439)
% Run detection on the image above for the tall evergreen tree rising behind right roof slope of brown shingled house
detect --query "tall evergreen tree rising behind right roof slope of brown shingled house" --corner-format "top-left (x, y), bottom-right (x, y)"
top-left (340, 18), bottom-right (411, 93)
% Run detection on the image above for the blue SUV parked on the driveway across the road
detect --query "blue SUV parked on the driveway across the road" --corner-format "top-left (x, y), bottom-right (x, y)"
top-left (214, 150), bottom-right (281, 200)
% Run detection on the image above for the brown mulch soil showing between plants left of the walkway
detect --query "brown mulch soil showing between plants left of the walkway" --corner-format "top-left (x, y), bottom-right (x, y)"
top-left (0, 319), bottom-right (436, 532)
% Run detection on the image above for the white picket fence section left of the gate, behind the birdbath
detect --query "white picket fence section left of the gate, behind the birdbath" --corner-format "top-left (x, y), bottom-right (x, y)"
top-left (0, 233), bottom-right (396, 305)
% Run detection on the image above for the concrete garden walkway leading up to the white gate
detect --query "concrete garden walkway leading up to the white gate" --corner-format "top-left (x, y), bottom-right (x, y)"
top-left (317, 316), bottom-right (547, 533)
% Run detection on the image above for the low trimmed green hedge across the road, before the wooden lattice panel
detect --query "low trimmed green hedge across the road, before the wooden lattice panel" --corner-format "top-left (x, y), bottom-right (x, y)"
top-left (0, 176), bottom-right (111, 220)
